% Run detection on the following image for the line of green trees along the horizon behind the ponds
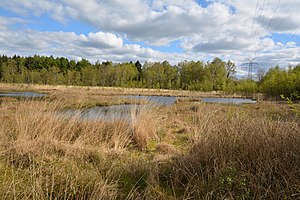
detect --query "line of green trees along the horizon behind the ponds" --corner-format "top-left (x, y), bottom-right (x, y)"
top-left (0, 55), bottom-right (300, 97)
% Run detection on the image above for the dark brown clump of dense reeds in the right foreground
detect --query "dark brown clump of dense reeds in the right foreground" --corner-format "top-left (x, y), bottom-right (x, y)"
top-left (162, 105), bottom-right (300, 199)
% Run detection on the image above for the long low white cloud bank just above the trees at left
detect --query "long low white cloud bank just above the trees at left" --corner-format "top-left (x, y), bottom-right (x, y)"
top-left (0, 25), bottom-right (173, 62)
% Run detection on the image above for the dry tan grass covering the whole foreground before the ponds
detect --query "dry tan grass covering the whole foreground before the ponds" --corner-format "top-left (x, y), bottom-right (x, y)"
top-left (0, 86), bottom-right (300, 199)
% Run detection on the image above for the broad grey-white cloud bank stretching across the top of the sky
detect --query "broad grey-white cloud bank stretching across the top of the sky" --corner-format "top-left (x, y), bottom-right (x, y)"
top-left (0, 0), bottom-right (300, 47)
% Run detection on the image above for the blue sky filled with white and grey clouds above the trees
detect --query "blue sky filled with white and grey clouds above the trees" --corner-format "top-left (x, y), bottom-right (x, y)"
top-left (0, 0), bottom-right (300, 76)
